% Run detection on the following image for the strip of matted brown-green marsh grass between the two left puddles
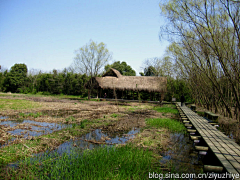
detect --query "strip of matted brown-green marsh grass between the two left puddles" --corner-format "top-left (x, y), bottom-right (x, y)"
top-left (0, 119), bottom-right (106, 166)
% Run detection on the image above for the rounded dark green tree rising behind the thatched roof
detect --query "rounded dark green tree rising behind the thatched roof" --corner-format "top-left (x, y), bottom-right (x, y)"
top-left (105, 61), bottom-right (136, 76)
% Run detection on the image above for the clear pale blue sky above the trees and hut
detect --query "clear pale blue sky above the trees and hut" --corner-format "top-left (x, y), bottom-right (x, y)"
top-left (0, 0), bottom-right (169, 75)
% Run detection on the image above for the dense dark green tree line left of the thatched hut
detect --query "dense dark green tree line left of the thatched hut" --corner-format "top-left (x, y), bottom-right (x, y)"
top-left (0, 64), bottom-right (89, 96)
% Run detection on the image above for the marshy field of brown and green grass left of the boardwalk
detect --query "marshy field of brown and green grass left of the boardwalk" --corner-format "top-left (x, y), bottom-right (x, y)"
top-left (0, 94), bottom-right (197, 179)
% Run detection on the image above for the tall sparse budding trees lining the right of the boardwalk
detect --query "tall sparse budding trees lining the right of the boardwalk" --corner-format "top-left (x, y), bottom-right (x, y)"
top-left (160, 0), bottom-right (240, 121)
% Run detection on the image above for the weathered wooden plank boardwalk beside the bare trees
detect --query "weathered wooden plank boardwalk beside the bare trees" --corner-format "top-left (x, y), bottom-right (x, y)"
top-left (177, 103), bottom-right (240, 174)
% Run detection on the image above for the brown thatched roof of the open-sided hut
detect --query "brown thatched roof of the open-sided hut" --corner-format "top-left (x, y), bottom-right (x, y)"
top-left (85, 68), bottom-right (167, 92)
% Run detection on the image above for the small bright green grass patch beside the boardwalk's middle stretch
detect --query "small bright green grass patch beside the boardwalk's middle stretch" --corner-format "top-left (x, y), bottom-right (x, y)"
top-left (146, 118), bottom-right (186, 133)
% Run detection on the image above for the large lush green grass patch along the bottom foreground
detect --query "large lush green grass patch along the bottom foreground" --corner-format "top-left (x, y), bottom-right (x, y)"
top-left (0, 145), bottom-right (161, 179)
